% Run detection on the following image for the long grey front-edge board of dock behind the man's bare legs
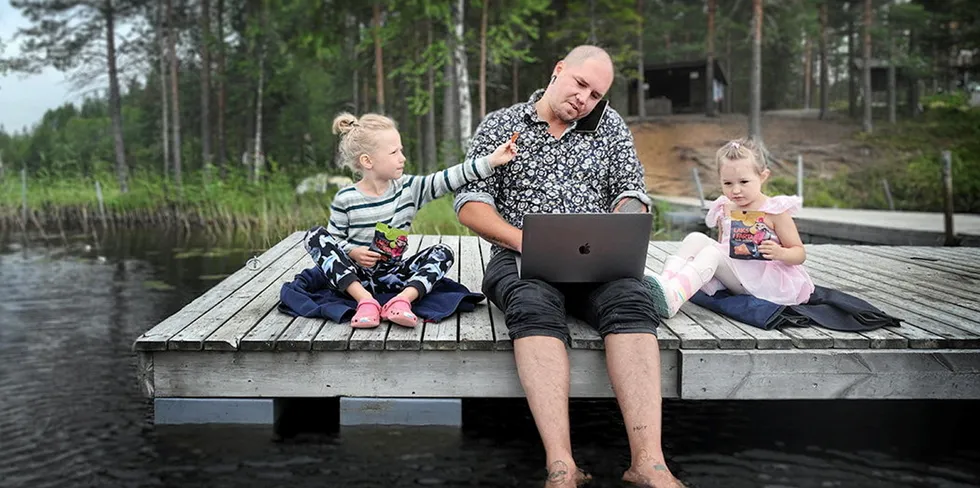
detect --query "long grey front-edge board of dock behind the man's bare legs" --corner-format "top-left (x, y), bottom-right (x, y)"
top-left (153, 349), bottom-right (679, 398)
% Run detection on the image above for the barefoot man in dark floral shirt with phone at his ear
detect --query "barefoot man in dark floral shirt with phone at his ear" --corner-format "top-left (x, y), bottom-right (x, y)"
top-left (455, 46), bottom-right (681, 488)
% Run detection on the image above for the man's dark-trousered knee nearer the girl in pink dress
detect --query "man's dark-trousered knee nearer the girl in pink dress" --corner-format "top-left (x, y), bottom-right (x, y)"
top-left (589, 278), bottom-right (661, 336)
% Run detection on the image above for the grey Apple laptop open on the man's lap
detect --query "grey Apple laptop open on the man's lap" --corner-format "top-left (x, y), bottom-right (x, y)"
top-left (517, 213), bottom-right (653, 283)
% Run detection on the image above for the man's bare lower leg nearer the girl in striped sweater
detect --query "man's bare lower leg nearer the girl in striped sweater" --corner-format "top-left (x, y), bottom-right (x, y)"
top-left (514, 336), bottom-right (585, 488)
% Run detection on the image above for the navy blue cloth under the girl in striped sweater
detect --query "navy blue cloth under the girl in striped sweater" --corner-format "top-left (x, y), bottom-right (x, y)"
top-left (279, 267), bottom-right (486, 323)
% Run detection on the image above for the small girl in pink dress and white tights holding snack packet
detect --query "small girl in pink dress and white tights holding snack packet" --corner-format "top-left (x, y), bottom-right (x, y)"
top-left (644, 139), bottom-right (814, 318)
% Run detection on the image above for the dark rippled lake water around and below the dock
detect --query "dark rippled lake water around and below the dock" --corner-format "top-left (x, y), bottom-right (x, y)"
top-left (0, 231), bottom-right (980, 488)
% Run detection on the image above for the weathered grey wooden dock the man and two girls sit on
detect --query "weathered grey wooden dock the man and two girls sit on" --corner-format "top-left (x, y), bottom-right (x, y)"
top-left (133, 233), bottom-right (980, 399)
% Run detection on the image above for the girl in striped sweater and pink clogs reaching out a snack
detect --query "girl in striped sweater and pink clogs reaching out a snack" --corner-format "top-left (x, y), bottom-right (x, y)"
top-left (303, 113), bottom-right (517, 328)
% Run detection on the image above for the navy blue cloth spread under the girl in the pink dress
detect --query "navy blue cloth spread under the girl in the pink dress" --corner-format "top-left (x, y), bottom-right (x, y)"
top-left (691, 286), bottom-right (902, 332)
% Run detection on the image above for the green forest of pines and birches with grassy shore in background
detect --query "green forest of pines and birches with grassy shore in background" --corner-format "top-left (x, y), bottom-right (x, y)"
top-left (0, 0), bottom-right (980, 232)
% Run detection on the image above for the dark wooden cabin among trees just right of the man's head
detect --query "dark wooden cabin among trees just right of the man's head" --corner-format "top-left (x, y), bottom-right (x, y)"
top-left (629, 59), bottom-right (728, 116)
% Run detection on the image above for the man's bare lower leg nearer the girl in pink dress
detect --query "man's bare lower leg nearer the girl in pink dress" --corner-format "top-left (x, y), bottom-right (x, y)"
top-left (605, 333), bottom-right (684, 488)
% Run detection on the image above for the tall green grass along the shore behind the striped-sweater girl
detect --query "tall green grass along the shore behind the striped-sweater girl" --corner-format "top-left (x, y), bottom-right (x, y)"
top-left (0, 165), bottom-right (470, 235)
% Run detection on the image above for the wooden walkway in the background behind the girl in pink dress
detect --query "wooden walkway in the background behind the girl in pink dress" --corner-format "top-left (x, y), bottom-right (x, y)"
top-left (651, 195), bottom-right (980, 247)
